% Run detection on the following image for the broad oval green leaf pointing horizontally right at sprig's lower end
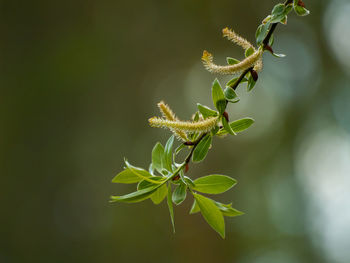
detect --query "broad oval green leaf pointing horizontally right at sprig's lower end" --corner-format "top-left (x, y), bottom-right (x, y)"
top-left (193, 174), bottom-right (237, 194)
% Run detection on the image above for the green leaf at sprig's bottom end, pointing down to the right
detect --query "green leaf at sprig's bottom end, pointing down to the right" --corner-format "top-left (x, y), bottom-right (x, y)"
top-left (193, 193), bottom-right (225, 238)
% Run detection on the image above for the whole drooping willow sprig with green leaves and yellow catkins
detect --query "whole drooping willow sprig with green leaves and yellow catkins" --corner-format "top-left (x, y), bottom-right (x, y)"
top-left (111, 0), bottom-right (310, 238)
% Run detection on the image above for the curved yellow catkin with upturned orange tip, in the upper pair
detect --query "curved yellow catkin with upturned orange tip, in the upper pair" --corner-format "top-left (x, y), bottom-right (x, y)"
top-left (202, 49), bottom-right (263, 75)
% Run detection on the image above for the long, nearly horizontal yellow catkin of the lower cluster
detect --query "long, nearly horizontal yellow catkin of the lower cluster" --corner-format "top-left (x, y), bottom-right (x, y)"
top-left (149, 117), bottom-right (218, 132)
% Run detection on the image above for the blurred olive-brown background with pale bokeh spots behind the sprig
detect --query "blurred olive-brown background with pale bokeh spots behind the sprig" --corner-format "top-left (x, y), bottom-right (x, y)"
top-left (0, 0), bottom-right (350, 263)
